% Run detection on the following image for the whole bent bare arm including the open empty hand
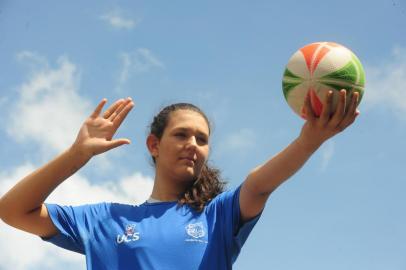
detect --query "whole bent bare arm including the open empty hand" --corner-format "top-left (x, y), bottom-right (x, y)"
top-left (0, 98), bottom-right (134, 237)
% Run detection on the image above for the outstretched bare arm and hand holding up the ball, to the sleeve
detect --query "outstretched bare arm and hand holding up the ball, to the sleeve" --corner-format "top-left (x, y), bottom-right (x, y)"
top-left (240, 90), bottom-right (359, 222)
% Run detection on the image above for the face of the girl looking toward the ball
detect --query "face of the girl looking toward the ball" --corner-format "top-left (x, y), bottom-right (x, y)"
top-left (152, 109), bottom-right (209, 182)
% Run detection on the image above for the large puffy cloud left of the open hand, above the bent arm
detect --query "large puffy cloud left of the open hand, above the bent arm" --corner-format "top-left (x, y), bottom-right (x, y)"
top-left (6, 52), bottom-right (91, 154)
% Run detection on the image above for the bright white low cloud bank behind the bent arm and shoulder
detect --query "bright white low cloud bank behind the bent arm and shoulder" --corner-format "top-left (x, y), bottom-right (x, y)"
top-left (0, 163), bottom-right (153, 270)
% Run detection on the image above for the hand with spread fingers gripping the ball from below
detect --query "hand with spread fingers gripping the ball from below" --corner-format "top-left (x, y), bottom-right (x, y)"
top-left (299, 89), bottom-right (359, 150)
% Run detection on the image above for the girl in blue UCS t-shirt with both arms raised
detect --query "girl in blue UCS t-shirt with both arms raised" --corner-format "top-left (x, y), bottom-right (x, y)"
top-left (0, 90), bottom-right (359, 269)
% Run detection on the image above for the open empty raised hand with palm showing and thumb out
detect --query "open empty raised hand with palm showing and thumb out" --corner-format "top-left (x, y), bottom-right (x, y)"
top-left (73, 98), bottom-right (134, 158)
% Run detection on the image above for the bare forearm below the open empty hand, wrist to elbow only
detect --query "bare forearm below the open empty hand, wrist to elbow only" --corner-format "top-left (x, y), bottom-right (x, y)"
top-left (0, 147), bottom-right (90, 218)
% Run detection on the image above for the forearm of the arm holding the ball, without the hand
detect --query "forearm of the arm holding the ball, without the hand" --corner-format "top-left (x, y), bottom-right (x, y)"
top-left (247, 137), bottom-right (320, 195)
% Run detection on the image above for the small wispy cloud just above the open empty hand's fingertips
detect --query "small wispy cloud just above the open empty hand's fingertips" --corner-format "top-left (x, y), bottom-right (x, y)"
top-left (118, 48), bottom-right (165, 87)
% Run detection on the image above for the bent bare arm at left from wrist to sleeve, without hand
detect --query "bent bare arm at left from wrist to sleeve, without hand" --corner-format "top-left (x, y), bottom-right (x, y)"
top-left (0, 146), bottom-right (90, 237)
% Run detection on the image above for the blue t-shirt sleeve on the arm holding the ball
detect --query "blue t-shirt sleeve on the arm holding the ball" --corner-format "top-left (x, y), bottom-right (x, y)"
top-left (209, 184), bottom-right (262, 262)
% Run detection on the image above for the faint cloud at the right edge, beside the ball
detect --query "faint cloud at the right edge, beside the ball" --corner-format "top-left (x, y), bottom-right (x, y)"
top-left (363, 47), bottom-right (406, 119)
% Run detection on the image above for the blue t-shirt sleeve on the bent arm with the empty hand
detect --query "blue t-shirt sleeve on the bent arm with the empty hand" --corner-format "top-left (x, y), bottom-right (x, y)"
top-left (41, 203), bottom-right (108, 254)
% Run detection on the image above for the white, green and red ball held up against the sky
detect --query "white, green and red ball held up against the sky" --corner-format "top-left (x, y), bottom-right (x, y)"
top-left (282, 42), bottom-right (365, 118)
